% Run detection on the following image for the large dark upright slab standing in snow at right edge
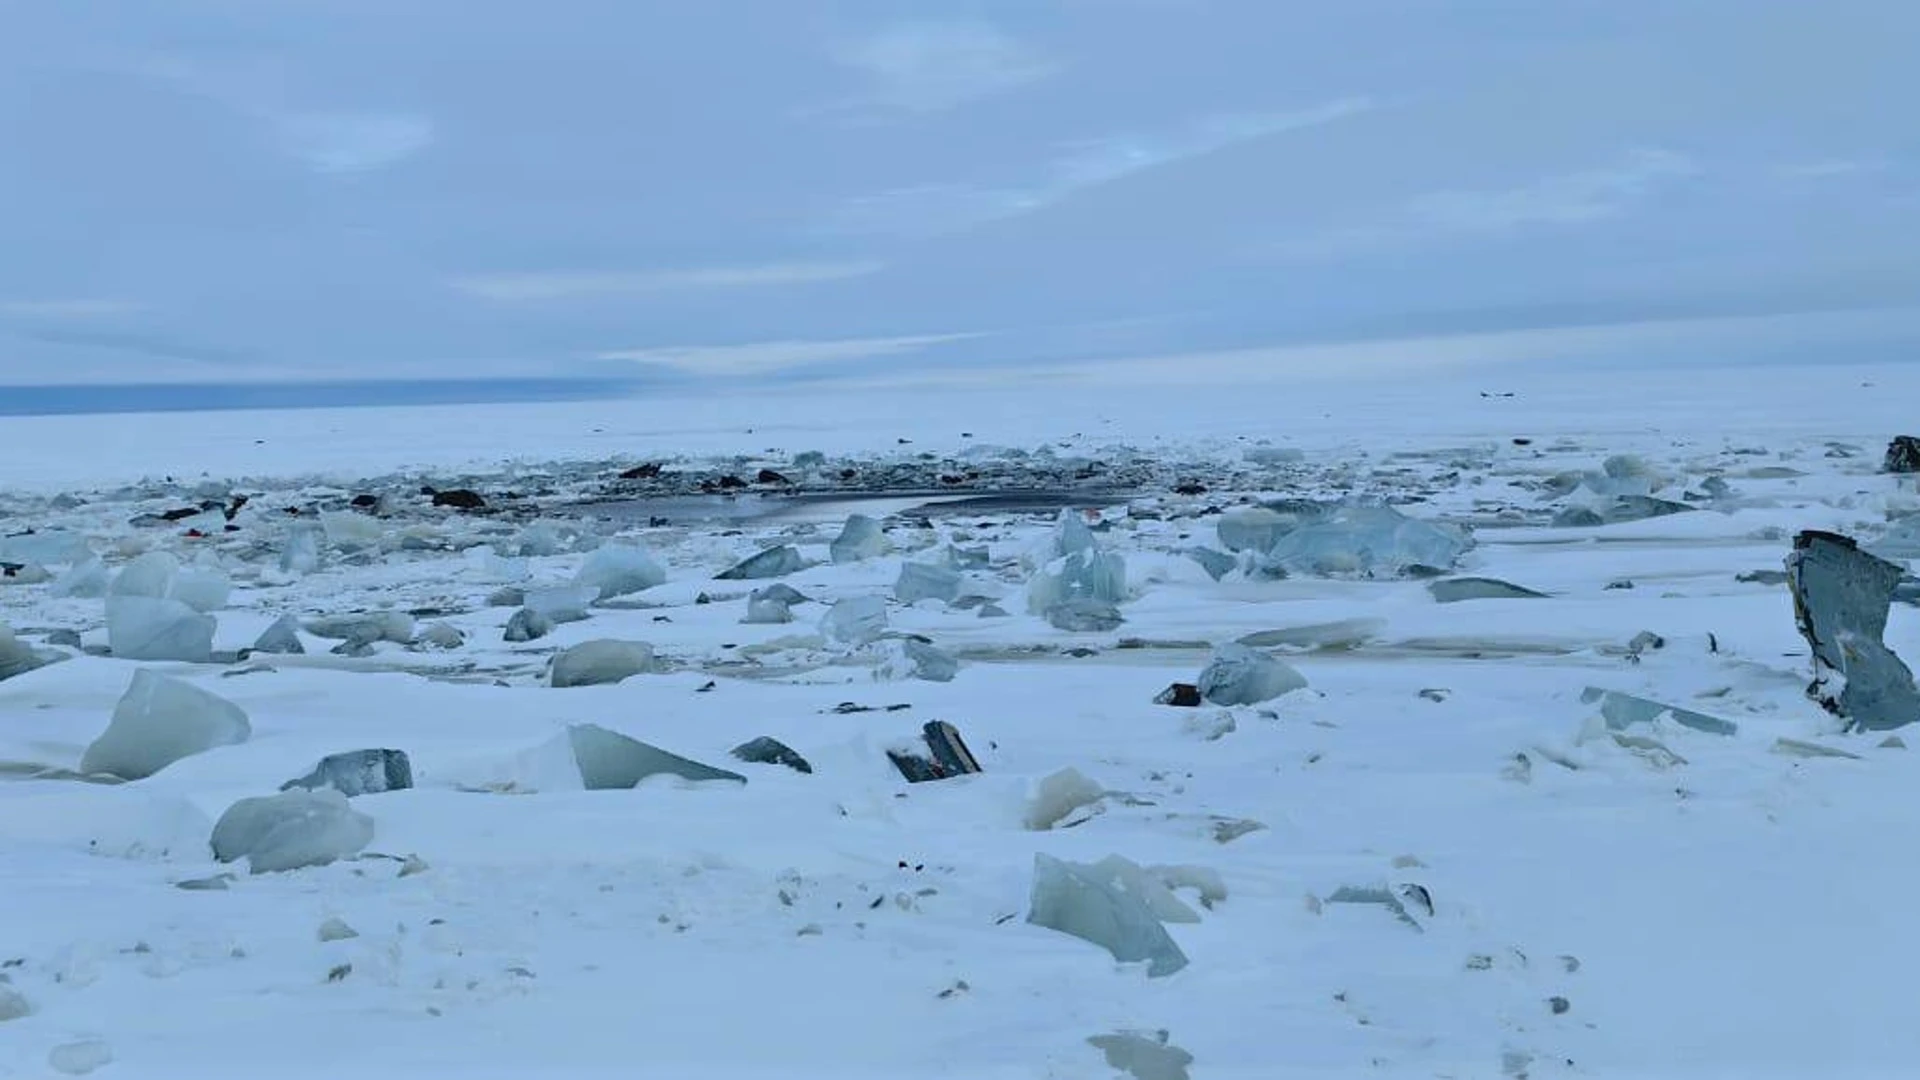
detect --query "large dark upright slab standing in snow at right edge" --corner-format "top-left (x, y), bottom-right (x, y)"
top-left (1788, 530), bottom-right (1920, 732)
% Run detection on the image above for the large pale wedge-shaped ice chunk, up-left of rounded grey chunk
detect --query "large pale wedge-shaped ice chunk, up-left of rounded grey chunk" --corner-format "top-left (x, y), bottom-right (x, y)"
top-left (81, 669), bottom-right (253, 780)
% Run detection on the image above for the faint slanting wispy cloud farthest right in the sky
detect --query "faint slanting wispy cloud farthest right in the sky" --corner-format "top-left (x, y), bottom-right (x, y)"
top-left (1277, 148), bottom-right (1701, 258)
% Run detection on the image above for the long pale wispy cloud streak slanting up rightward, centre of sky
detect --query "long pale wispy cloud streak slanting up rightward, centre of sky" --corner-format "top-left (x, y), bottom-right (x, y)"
top-left (826, 98), bottom-right (1377, 236)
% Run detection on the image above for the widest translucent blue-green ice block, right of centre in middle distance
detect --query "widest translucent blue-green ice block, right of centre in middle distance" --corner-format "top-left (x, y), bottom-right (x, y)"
top-left (1263, 505), bottom-right (1473, 577)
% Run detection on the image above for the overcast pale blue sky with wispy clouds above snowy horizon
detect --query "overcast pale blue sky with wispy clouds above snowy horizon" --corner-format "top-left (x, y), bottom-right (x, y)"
top-left (0, 0), bottom-right (1920, 384)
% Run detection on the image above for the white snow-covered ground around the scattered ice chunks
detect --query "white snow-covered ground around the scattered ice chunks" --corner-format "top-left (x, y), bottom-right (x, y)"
top-left (0, 365), bottom-right (1920, 1080)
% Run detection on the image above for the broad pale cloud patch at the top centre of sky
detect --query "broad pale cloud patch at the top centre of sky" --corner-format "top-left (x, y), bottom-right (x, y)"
top-left (824, 21), bottom-right (1060, 113)
